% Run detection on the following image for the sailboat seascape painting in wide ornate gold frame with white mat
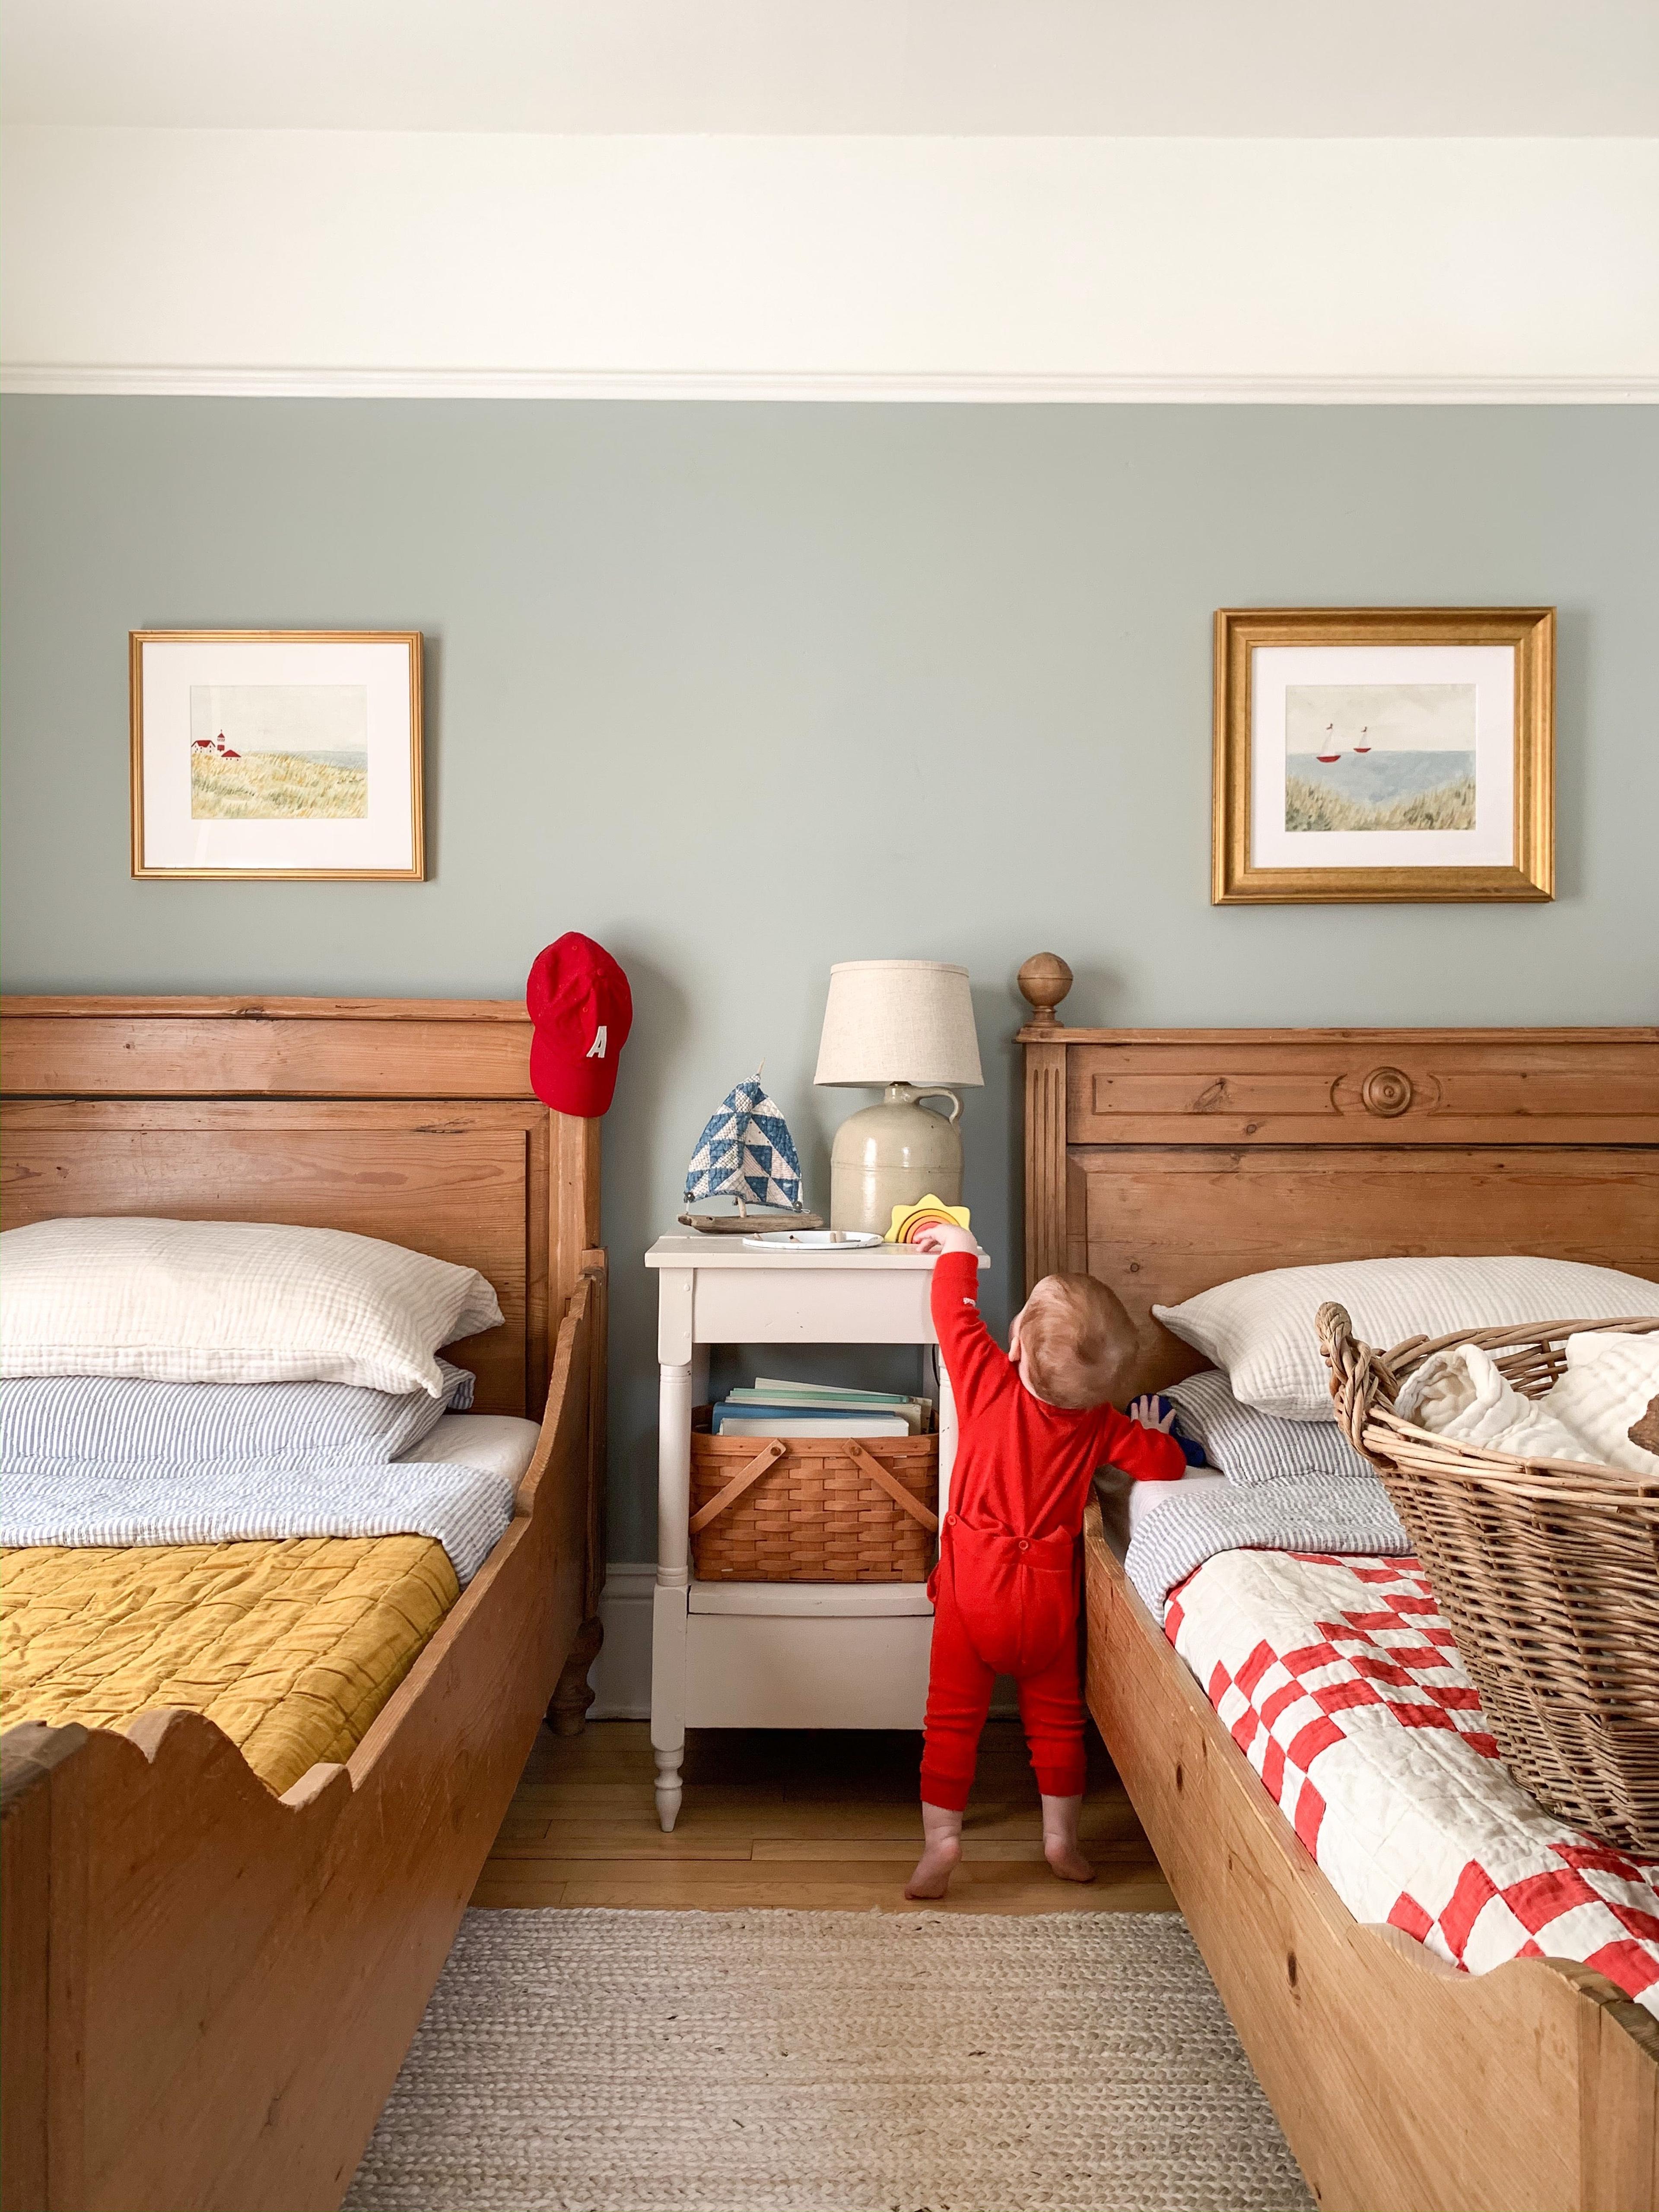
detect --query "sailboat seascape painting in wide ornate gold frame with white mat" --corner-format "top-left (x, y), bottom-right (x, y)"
top-left (1210, 606), bottom-right (1555, 907)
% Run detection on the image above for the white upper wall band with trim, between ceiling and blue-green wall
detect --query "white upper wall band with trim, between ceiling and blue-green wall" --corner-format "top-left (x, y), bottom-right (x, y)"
top-left (13, 128), bottom-right (1659, 405)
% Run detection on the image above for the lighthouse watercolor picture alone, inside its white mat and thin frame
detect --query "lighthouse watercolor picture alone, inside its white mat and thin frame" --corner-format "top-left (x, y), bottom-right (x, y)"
top-left (190, 683), bottom-right (369, 821)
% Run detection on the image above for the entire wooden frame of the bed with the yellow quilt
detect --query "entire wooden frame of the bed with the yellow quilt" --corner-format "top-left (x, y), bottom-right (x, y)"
top-left (0, 998), bottom-right (606, 2212)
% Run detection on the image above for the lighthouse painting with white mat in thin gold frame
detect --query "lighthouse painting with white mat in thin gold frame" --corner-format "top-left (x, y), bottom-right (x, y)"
top-left (128, 630), bottom-right (427, 883)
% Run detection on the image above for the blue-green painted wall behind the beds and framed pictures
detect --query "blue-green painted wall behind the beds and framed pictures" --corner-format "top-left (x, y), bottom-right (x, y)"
top-left (0, 411), bottom-right (1659, 1557)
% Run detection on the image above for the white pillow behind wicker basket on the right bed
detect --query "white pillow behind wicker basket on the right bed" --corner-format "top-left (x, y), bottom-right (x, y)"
top-left (1153, 1259), bottom-right (1659, 1420)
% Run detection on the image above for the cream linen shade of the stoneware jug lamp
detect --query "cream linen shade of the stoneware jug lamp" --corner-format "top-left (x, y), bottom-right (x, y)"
top-left (812, 960), bottom-right (984, 1090)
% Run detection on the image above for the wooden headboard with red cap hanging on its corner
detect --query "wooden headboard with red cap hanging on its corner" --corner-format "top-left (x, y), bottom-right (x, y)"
top-left (0, 998), bottom-right (600, 1420)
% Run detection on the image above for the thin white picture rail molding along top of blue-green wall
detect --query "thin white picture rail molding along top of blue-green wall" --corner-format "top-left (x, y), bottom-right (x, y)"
top-left (0, 361), bottom-right (1659, 407)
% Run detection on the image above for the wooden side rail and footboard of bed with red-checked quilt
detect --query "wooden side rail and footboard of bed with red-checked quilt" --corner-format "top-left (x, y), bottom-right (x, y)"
top-left (1086, 1509), bottom-right (1659, 2212)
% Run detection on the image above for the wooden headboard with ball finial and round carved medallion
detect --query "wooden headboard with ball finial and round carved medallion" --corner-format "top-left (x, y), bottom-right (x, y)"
top-left (1020, 953), bottom-right (1659, 1389)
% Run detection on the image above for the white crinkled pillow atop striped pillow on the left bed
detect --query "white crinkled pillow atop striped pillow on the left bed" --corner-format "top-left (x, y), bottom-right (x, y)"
top-left (0, 1219), bottom-right (502, 1398)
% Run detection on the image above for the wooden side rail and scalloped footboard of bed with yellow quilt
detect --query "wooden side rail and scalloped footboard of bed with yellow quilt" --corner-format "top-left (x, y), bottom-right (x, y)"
top-left (0, 1252), bottom-right (604, 2212)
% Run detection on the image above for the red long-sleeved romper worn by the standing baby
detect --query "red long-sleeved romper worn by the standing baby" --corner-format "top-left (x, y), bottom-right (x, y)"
top-left (922, 1252), bottom-right (1185, 1812)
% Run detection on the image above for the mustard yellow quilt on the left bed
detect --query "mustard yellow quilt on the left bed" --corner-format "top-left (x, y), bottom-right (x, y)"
top-left (0, 1535), bottom-right (460, 1794)
